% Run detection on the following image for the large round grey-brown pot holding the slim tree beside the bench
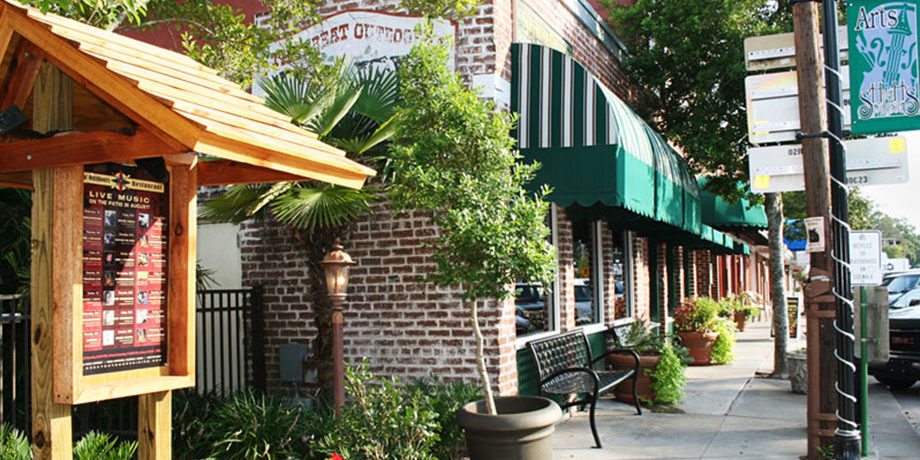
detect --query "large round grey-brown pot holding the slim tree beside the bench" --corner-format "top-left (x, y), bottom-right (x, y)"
top-left (457, 396), bottom-right (562, 460)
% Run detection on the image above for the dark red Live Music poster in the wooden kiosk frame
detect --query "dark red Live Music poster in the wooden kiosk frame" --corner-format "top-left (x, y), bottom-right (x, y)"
top-left (83, 163), bottom-right (169, 375)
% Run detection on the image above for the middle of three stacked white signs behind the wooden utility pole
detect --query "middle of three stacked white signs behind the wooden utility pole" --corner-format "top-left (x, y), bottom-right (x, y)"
top-left (744, 66), bottom-right (850, 145)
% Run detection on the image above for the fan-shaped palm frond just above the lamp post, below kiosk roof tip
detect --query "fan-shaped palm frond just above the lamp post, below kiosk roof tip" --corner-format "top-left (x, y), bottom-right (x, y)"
top-left (271, 185), bottom-right (376, 229)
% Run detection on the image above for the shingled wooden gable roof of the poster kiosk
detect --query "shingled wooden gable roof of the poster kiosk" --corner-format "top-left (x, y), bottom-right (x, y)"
top-left (0, 1), bottom-right (375, 188)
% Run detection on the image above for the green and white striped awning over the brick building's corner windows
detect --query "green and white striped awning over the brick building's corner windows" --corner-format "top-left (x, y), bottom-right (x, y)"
top-left (511, 43), bottom-right (702, 235)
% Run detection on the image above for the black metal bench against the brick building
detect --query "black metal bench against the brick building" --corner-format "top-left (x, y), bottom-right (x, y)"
top-left (527, 329), bottom-right (642, 448)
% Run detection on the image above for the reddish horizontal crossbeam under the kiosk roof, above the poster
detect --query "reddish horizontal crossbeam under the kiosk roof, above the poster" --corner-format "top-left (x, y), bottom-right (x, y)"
top-left (0, 130), bottom-right (182, 172)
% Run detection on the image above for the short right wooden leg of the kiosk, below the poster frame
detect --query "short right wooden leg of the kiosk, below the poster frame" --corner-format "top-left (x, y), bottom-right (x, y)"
top-left (137, 391), bottom-right (172, 460)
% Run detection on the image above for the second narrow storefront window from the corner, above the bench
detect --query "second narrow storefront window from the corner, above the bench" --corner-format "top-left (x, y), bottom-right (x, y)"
top-left (572, 221), bottom-right (603, 326)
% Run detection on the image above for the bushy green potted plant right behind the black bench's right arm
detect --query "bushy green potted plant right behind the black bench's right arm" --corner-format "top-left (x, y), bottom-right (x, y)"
top-left (607, 321), bottom-right (686, 404)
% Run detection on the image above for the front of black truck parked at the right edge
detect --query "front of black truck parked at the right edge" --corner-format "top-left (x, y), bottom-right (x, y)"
top-left (869, 305), bottom-right (920, 389)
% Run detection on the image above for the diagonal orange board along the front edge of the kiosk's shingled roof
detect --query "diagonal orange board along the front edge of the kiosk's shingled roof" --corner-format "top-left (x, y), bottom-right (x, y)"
top-left (4, 8), bottom-right (195, 150)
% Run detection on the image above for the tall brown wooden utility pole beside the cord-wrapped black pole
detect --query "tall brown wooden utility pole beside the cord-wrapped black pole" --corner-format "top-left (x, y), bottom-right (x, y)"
top-left (792, 2), bottom-right (837, 460)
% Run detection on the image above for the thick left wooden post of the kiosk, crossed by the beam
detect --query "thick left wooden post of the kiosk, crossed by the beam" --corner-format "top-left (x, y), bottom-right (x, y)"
top-left (31, 64), bottom-right (74, 460)
